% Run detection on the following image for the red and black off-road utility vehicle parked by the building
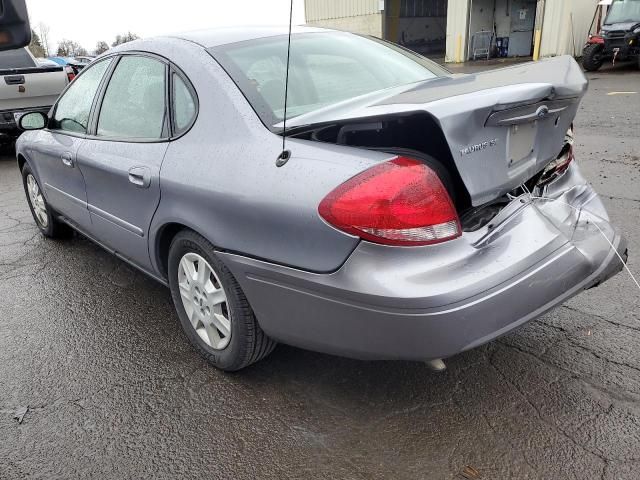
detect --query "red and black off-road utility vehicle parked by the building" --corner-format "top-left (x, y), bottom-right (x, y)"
top-left (582, 0), bottom-right (640, 72)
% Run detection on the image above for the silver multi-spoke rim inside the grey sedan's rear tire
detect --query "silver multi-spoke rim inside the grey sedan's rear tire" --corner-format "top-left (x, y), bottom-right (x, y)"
top-left (178, 253), bottom-right (231, 350)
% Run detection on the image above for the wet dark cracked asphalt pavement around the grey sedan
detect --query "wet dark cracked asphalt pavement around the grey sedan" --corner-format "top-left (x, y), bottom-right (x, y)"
top-left (0, 63), bottom-right (640, 480)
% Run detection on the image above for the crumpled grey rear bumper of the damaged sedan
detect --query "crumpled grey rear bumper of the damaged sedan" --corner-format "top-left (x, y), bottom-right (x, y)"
top-left (219, 165), bottom-right (627, 360)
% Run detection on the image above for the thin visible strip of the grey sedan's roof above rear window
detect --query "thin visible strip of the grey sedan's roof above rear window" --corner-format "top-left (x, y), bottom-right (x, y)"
top-left (171, 25), bottom-right (329, 48)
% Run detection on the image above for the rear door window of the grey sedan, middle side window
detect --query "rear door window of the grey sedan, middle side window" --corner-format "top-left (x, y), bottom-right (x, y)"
top-left (97, 56), bottom-right (167, 140)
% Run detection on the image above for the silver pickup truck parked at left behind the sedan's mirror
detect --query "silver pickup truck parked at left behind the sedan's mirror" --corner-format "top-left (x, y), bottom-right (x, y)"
top-left (0, 48), bottom-right (70, 144)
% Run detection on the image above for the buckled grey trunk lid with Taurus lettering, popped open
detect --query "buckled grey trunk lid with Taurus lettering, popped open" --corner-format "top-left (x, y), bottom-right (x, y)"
top-left (276, 56), bottom-right (587, 206)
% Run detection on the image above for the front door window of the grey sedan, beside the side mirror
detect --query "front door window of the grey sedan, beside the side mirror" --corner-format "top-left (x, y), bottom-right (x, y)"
top-left (51, 58), bottom-right (112, 133)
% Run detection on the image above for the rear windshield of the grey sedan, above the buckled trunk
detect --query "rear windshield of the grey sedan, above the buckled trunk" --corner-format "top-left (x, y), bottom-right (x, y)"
top-left (209, 32), bottom-right (448, 126)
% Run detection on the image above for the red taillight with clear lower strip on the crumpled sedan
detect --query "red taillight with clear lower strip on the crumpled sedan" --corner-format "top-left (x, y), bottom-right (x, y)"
top-left (318, 157), bottom-right (461, 246)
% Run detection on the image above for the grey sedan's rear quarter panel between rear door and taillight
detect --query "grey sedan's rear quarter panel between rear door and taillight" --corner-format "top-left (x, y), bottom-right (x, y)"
top-left (142, 36), bottom-right (384, 272)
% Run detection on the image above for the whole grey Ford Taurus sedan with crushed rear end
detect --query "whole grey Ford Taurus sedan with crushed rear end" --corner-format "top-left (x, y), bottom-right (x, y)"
top-left (12, 28), bottom-right (626, 370)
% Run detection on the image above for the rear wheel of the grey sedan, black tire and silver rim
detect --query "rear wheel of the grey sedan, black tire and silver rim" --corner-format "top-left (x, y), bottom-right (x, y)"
top-left (168, 230), bottom-right (276, 372)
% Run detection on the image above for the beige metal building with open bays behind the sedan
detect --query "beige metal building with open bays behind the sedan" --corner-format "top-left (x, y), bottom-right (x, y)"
top-left (305, 0), bottom-right (598, 62)
